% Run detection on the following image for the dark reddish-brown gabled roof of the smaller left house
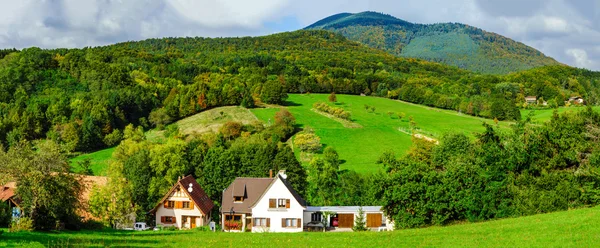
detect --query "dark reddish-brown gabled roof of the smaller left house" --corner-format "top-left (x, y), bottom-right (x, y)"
top-left (150, 176), bottom-right (215, 215)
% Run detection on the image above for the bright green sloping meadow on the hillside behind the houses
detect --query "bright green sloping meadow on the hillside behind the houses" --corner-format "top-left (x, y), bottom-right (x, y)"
top-left (252, 94), bottom-right (508, 173)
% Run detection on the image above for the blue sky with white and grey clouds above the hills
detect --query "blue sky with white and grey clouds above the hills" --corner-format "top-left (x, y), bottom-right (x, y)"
top-left (0, 0), bottom-right (600, 71)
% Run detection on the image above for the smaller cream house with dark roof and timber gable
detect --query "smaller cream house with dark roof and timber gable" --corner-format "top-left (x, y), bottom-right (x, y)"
top-left (150, 176), bottom-right (215, 229)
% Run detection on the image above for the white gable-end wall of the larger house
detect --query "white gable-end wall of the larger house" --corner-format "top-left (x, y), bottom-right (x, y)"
top-left (252, 179), bottom-right (302, 232)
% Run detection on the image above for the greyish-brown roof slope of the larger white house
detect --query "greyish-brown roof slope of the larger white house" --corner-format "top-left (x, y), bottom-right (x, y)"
top-left (221, 177), bottom-right (274, 213)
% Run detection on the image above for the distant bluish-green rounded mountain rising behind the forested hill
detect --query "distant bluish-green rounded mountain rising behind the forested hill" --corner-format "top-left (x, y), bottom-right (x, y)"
top-left (305, 12), bottom-right (560, 74)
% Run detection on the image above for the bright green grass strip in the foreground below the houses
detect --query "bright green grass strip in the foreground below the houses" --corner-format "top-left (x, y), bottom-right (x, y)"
top-left (0, 207), bottom-right (600, 247)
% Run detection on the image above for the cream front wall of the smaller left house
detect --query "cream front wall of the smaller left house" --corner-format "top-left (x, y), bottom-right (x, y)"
top-left (156, 193), bottom-right (208, 229)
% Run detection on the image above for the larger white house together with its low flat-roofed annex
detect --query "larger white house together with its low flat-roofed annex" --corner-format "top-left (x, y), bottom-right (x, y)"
top-left (221, 171), bottom-right (393, 232)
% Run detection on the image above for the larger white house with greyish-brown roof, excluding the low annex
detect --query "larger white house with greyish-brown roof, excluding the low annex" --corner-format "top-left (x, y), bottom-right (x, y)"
top-left (221, 171), bottom-right (306, 232)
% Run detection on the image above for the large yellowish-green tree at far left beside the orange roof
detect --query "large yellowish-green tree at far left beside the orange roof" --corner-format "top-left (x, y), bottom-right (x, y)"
top-left (0, 141), bottom-right (82, 230)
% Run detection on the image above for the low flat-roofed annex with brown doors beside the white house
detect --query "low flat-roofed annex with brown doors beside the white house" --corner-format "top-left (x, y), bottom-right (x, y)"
top-left (304, 206), bottom-right (394, 231)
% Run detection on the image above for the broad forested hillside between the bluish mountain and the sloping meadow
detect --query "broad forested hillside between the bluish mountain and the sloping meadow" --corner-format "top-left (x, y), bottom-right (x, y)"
top-left (0, 31), bottom-right (600, 152)
